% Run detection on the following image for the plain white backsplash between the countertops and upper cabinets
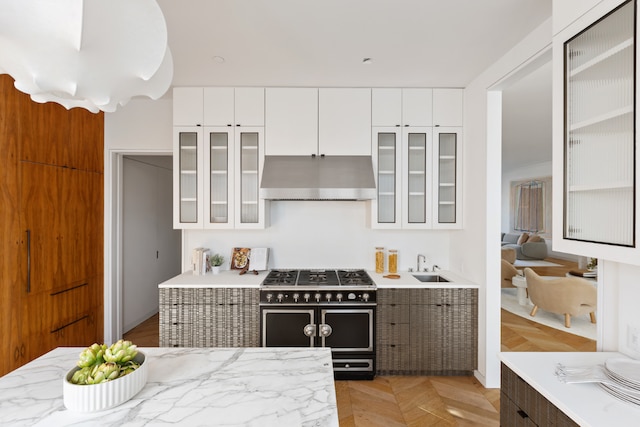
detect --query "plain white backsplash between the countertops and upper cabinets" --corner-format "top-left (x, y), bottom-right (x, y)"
top-left (183, 201), bottom-right (455, 271)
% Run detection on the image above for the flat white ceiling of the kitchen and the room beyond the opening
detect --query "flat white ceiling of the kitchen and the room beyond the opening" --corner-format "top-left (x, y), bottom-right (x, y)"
top-left (158, 0), bottom-right (551, 170)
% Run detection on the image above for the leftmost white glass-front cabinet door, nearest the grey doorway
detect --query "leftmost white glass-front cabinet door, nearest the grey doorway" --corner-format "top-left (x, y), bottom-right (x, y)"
top-left (173, 127), bottom-right (203, 228)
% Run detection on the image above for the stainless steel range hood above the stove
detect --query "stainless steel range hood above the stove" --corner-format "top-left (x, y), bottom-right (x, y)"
top-left (260, 156), bottom-right (376, 200)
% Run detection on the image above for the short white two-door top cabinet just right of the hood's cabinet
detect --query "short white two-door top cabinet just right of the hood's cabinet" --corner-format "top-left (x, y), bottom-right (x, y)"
top-left (371, 88), bottom-right (433, 127)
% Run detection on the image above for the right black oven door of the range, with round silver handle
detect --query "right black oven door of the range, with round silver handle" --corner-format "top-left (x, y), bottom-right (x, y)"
top-left (318, 308), bottom-right (375, 352)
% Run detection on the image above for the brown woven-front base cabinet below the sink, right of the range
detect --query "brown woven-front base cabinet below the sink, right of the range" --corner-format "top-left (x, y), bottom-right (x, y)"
top-left (376, 288), bottom-right (478, 375)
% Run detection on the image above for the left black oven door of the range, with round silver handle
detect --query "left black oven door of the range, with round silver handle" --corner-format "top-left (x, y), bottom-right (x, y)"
top-left (262, 307), bottom-right (316, 347)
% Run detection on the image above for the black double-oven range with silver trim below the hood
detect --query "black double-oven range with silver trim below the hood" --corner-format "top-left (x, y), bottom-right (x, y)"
top-left (260, 269), bottom-right (376, 379)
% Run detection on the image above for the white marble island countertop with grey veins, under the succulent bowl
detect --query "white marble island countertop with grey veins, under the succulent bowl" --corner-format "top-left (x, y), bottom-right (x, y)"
top-left (0, 348), bottom-right (338, 426)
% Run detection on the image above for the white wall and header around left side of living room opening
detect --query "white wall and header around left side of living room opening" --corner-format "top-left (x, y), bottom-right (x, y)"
top-left (458, 20), bottom-right (551, 388)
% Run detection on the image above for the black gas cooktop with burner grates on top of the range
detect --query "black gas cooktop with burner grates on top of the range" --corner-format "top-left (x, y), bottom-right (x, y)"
top-left (261, 269), bottom-right (375, 289)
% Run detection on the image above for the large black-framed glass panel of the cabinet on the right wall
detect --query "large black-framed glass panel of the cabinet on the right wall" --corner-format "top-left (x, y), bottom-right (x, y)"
top-left (563, 1), bottom-right (636, 246)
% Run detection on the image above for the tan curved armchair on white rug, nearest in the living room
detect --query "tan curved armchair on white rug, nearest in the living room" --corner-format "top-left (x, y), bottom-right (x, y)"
top-left (524, 268), bottom-right (597, 328)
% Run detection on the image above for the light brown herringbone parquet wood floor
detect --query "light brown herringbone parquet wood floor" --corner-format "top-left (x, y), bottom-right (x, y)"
top-left (124, 260), bottom-right (596, 427)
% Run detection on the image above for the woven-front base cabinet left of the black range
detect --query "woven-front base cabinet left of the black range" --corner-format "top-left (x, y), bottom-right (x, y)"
top-left (160, 288), bottom-right (259, 347)
